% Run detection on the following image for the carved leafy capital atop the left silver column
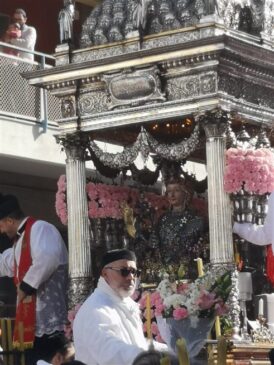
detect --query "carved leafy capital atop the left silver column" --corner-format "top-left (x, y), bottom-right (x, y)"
top-left (55, 132), bottom-right (89, 161)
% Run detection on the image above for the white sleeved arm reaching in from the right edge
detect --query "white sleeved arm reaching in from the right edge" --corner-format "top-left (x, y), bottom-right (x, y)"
top-left (233, 193), bottom-right (274, 252)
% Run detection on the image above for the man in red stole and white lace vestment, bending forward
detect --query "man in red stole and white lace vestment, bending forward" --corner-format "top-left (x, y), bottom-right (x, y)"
top-left (0, 194), bottom-right (68, 365)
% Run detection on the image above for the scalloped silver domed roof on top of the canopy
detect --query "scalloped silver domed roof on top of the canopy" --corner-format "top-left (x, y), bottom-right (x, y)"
top-left (80, 0), bottom-right (274, 47)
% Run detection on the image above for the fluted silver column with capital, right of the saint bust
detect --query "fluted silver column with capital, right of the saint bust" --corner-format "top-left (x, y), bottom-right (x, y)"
top-left (203, 110), bottom-right (234, 264)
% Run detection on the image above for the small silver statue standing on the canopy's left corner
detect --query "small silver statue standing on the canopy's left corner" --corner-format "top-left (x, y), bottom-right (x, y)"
top-left (58, 0), bottom-right (75, 43)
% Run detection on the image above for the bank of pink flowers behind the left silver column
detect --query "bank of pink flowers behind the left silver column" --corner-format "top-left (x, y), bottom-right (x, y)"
top-left (55, 175), bottom-right (168, 225)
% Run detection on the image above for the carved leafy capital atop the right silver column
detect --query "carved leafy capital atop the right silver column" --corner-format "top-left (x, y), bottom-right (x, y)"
top-left (195, 108), bottom-right (230, 139)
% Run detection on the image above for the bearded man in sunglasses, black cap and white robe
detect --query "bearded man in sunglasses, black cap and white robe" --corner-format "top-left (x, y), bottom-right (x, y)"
top-left (73, 249), bottom-right (168, 365)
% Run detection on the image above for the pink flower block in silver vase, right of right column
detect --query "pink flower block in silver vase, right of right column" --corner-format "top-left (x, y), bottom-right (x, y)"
top-left (224, 148), bottom-right (274, 195)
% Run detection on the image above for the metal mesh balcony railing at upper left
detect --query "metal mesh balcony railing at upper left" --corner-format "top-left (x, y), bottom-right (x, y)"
top-left (0, 42), bottom-right (61, 131)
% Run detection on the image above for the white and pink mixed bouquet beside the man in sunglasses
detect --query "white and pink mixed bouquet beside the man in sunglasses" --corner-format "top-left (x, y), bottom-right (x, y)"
top-left (153, 269), bottom-right (231, 320)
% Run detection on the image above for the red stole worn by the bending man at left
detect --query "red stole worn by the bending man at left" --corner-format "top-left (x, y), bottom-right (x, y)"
top-left (13, 217), bottom-right (36, 349)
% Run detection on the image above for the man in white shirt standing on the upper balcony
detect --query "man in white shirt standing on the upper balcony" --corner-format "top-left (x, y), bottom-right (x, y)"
top-left (10, 9), bottom-right (37, 61)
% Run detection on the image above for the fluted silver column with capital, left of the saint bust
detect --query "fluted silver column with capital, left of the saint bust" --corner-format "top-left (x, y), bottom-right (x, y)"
top-left (58, 133), bottom-right (92, 308)
